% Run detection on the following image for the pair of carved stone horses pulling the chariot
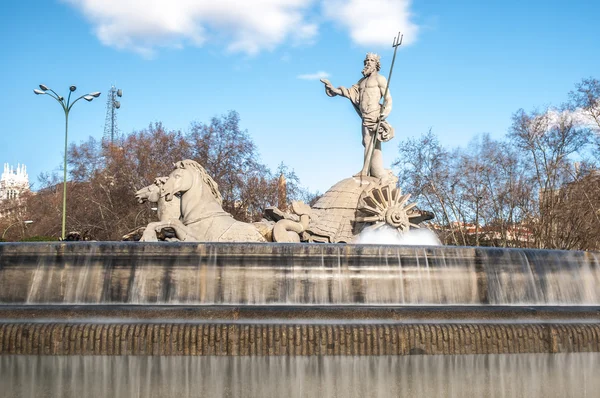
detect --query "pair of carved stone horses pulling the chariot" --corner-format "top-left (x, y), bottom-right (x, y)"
top-left (136, 159), bottom-right (266, 242)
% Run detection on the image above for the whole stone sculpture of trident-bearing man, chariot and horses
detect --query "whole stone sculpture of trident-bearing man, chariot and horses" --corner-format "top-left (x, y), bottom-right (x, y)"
top-left (124, 34), bottom-right (434, 243)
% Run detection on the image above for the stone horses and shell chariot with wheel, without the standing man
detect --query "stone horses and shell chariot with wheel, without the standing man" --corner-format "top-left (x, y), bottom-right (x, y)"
top-left (130, 160), bottom-right (433, 243)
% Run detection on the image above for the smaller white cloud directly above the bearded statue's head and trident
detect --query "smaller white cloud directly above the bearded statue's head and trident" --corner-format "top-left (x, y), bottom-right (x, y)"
top-left (322, 0), bottom-right (419, 47)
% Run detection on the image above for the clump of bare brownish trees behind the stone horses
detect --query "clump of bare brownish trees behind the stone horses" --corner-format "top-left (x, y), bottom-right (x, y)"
top-left (21, 112), bottom-right (318, 240)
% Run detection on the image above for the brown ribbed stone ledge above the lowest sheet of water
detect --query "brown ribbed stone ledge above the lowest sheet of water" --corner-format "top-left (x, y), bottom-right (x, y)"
top-left (0, 323), bottom-right (600, 356)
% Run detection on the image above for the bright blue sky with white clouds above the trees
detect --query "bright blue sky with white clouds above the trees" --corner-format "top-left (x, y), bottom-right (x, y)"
top-left (0, 0), bottom-right (600, 192)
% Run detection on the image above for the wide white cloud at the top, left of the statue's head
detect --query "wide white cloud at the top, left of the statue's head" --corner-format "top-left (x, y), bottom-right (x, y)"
top-left (62, 0), bottom-right (317, 56)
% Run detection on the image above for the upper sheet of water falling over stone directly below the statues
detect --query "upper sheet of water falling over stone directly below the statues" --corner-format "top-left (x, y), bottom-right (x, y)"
top-left (0, 244), bottom-right (600, 305)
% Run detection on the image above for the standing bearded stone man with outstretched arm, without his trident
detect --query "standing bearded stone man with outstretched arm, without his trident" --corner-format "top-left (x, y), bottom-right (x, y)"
top-left (321, 53), bottom-right (394, 178)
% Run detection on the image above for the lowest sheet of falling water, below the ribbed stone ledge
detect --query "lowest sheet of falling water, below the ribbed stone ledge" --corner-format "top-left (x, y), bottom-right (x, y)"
top-left (0, 353), bottom-right (600, 398)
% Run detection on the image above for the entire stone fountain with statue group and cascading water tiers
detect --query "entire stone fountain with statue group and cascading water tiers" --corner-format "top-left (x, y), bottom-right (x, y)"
top-left (0, 49), bottom-right (600, 398)
